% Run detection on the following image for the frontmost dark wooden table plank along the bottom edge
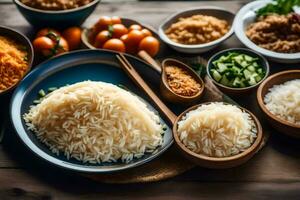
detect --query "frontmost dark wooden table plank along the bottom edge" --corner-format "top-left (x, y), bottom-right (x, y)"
top-left (0, 169), bottom-right (300, 200)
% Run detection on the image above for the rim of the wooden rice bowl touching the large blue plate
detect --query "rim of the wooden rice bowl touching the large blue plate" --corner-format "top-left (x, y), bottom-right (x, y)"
top-left (173, 102), bottom-right (263, 163)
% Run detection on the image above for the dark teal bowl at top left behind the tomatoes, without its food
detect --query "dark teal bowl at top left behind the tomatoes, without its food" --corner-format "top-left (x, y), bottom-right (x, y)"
top-left (14, 0), bottom-right (100, 28)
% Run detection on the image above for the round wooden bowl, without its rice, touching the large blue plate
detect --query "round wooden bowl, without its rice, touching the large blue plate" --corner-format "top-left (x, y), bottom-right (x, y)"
top-left (173, 102), bottom-right (263, 169)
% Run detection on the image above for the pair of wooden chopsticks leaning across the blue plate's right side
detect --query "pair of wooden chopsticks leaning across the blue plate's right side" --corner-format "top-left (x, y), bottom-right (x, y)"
top-left (116, 53), bottom-right (177, 125)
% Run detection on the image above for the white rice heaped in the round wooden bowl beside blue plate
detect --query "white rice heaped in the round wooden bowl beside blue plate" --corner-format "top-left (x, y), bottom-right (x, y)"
top-left (178, 102), bottom-right (257, 157)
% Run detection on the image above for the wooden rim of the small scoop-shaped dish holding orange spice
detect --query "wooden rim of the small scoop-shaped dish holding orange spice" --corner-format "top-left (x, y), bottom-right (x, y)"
top-left (161, 58), bottom-right (205, 101)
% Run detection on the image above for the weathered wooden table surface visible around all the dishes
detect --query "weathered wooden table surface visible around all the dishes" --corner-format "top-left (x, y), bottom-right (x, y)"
top-left (0, 1), bottom-right (300, 200)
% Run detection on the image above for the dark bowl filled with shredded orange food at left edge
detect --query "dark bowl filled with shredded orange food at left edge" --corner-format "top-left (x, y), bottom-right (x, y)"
top-left (0, 26), bottom-right (33, 95)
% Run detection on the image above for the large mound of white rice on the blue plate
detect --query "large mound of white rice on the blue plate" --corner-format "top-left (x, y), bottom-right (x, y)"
top-left (24, 81), bottom-right (163, 163)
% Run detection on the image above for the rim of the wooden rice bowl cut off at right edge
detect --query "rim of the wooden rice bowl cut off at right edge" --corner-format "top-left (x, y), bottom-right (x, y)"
top-left (256, 69), bottom-right (300, 129)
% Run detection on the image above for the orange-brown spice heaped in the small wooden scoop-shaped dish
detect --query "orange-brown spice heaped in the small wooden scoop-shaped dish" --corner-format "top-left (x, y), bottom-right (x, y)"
top-left (165, 66), bottom-right (201, 97)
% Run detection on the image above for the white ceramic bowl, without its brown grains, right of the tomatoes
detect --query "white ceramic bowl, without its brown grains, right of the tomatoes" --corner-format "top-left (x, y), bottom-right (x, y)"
top-left (158, 6), bottom-right (234, 53)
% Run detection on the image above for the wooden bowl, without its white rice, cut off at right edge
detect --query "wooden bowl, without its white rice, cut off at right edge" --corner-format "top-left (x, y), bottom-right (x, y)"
top-left (257, 70), bottom-right (300, 138)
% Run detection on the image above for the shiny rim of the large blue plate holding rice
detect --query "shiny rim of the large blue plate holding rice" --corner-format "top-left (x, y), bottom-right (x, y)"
top-left (10, 50), bottom-right (174, 173)
